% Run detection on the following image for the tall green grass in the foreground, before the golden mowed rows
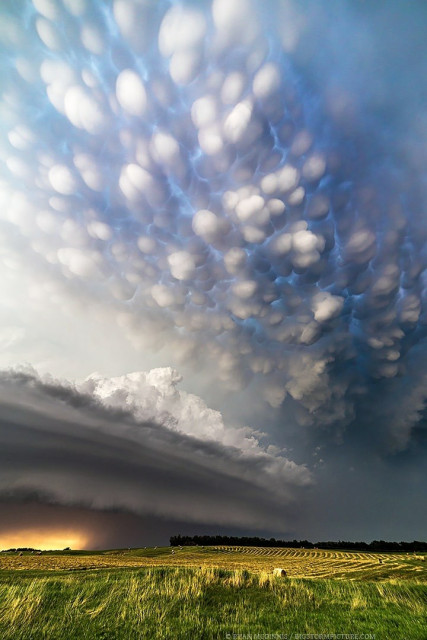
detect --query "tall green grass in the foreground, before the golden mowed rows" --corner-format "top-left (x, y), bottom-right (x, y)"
top-left (0, 567), bottom-right (427, 640)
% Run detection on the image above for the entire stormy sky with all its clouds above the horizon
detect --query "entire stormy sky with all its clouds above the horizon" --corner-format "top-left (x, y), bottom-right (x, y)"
top-left (0, 0), bottom-right (427, 548)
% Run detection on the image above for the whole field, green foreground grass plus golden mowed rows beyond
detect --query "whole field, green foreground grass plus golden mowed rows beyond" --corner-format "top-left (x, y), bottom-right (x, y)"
top-left (0, 547), bottom-right (427, 640)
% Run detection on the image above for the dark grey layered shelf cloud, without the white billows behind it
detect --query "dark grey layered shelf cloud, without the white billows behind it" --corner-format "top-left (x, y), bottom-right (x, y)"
top-left (0, 372), bottom-right (310, 528)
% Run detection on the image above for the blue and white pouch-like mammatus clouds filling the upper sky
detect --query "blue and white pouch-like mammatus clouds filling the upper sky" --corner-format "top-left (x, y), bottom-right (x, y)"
top-left (0, 0), bottom-right (427, 460)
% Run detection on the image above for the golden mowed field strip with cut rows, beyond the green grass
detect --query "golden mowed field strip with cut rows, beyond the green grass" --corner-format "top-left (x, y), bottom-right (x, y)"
top-left (0, 547), bottom-right (427, 582)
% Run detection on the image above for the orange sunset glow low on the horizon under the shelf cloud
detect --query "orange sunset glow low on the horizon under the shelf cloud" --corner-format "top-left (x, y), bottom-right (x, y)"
top-left (0, 529), bottom-right (88, 551)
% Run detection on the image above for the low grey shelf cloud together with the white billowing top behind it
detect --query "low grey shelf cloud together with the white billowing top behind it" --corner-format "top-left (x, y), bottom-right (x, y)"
top-left (0, 370), bottom-right (312, 531)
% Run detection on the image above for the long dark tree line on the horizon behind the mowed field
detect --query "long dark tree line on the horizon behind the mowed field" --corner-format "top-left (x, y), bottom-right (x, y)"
top-left (170, 535), bottom-right (427, 551)
